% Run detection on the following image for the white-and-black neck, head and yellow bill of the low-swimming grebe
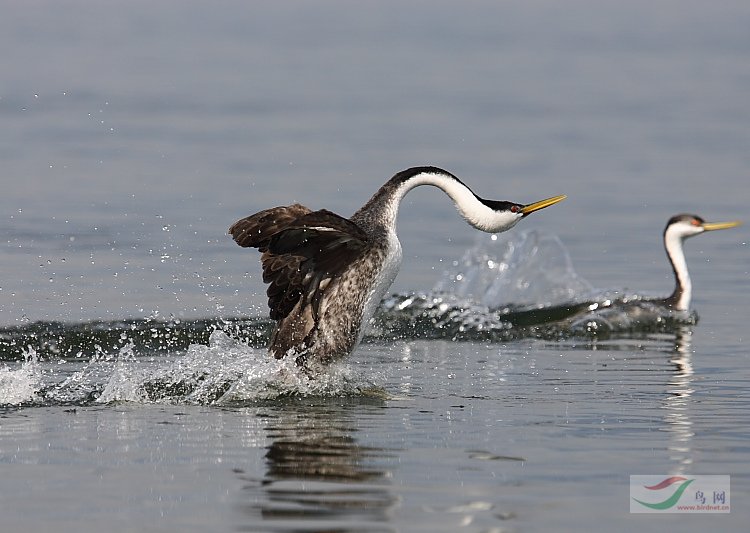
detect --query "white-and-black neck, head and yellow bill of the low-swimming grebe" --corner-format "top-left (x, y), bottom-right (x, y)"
top-left (660, 214), bottom-right (741, 311)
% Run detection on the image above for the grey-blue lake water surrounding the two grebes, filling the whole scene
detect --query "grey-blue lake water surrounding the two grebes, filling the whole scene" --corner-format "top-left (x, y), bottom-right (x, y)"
top-left (0, 0), bottom-right (750, 532)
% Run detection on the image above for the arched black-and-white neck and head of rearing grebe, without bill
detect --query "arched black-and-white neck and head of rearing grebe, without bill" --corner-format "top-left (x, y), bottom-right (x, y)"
top-left (352, 167), bottom-right (522, 233)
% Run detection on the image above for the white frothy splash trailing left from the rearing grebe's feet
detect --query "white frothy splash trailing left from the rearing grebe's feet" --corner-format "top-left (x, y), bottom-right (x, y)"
top-left (0, 329), bottom-right (376, 405)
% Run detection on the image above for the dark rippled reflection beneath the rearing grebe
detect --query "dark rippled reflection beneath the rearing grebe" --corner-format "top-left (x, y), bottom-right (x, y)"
top-left (236, 398), bottom-right (397, 531)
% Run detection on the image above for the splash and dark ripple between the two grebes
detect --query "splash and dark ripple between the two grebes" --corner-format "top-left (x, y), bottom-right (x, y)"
top-left (376, 230), bottom-right (697, 341)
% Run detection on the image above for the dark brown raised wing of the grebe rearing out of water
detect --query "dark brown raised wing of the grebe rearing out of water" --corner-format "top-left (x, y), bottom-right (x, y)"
top-left (229, 204), bottom-right (369, 320)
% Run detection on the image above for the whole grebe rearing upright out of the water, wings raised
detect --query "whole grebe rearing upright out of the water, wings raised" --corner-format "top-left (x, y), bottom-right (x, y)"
top-left (229, 166), bottom-right (565, 364)
